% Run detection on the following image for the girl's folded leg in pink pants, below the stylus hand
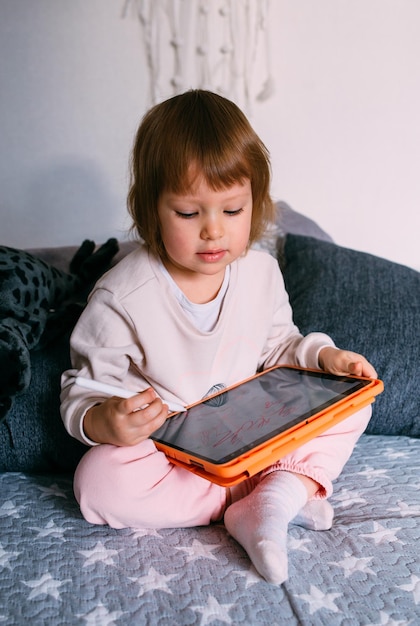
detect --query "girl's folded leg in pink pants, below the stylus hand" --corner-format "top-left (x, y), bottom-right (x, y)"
top-left (74, 440), bottom-right (226, 528)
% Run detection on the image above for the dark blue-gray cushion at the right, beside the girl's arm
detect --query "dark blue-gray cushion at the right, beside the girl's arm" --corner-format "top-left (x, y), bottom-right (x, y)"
top-left (280, 234), bottom-right (420, 437)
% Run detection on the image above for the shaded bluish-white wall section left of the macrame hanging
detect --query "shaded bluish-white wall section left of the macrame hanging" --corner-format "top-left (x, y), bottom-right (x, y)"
top-left (0, 0), bottom-right (146, 247)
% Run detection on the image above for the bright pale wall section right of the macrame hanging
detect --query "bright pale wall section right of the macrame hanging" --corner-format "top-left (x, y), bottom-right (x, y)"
top-left (260, 0), bottom-right (420, 269)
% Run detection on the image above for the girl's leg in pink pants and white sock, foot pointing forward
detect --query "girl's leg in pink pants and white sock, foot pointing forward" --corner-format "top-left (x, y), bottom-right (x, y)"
top-left (225, 407), bottom-right (371, 584)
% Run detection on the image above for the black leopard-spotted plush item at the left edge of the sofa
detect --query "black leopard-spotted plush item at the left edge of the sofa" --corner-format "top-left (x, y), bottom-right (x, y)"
top-left (0, 239), bottom-right (118, 420)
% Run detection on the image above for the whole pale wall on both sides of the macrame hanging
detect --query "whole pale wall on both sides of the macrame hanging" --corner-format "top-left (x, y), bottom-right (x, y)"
top-left (0, 0), bottom-right (420, 269)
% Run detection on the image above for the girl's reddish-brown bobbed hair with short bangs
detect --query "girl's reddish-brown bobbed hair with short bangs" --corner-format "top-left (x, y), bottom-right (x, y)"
top-left (127, 89), bottom-right (274, 256)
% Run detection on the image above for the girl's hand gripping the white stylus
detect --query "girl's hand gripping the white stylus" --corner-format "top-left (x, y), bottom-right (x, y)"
top-left (83, 388), bottom-right (169, 446)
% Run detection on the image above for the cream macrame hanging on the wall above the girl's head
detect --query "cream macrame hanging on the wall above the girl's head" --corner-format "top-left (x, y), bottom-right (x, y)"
top-left (123, 0), bottom-right (274, 114)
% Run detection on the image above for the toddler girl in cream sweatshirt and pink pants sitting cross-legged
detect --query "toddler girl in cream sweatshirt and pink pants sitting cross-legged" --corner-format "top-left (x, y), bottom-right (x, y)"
top-left (62, 90), bottom-right (376, 584)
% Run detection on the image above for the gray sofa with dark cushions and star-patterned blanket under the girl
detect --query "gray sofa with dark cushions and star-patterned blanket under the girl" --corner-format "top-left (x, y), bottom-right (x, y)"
top-left (0, 203), bottom-right (420, 626)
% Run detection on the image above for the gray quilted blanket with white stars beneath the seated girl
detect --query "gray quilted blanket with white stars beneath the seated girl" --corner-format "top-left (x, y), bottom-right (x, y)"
top-left (0, 435), bottom-right (420, 626)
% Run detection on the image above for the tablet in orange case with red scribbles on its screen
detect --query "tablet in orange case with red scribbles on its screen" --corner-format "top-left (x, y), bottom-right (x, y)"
top-left (151, 366), bottom-right (383, 486)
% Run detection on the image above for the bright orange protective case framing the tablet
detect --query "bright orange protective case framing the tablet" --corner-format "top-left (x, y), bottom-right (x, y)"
top-left (151, 365), bottom-right (383, 487)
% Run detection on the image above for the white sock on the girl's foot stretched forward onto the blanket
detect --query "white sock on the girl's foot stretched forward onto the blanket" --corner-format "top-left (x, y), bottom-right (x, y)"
top-left (224, 471), bottom-right (308, 585)
